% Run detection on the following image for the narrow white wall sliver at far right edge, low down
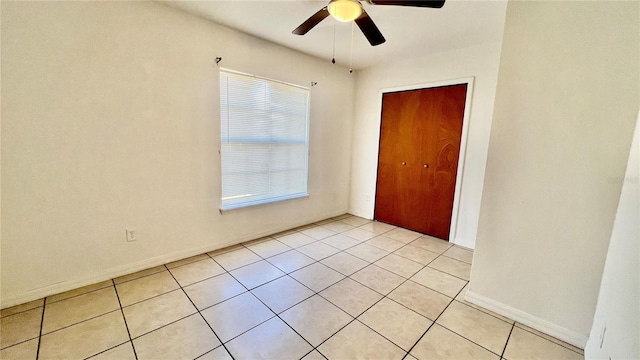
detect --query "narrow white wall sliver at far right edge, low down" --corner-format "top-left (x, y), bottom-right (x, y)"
top-left (584, 114), bottom-right (640, 359)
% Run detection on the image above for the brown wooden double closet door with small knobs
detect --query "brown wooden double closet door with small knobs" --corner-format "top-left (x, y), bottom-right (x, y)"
top-left (374, 84), bottom-right (467, 240)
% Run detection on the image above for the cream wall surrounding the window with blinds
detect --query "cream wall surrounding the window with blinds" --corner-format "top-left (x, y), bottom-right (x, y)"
top-left (0, 1), bottom-right (354, 307)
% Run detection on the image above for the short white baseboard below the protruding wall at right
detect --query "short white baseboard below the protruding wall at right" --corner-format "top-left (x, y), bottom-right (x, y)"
top-left (464, 290), bottom-right (589, 349)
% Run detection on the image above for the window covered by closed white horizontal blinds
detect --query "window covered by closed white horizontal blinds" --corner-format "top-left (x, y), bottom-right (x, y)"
top-left (220, 70), bottom-right (309, 210)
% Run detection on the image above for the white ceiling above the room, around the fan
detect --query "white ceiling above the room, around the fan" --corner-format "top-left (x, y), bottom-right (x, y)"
top-left (163, 0), bottom-right (506, 70)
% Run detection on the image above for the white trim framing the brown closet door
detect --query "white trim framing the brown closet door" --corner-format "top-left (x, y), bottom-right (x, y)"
top-left (371, 76), bottom-right (475, 244)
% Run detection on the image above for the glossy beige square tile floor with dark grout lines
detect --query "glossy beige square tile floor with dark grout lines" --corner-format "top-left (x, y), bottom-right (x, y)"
top-left (0, 215), bottom-right (584, 360)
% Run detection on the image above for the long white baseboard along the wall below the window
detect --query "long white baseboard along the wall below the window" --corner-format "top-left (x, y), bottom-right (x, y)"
top-left (0, 210), bottom-right (346, 309)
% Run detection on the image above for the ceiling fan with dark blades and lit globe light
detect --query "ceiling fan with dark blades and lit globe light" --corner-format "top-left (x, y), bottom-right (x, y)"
top-left (293, 0), bottom-right (445, 46)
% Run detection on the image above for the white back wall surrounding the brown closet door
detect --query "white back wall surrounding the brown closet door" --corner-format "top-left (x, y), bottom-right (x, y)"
top-left (349, 37), bottom-right (506, 248)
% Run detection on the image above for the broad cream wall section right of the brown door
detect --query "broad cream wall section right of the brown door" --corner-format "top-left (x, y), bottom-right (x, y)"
top-left (467, 1), bottom-right (640, 346)
